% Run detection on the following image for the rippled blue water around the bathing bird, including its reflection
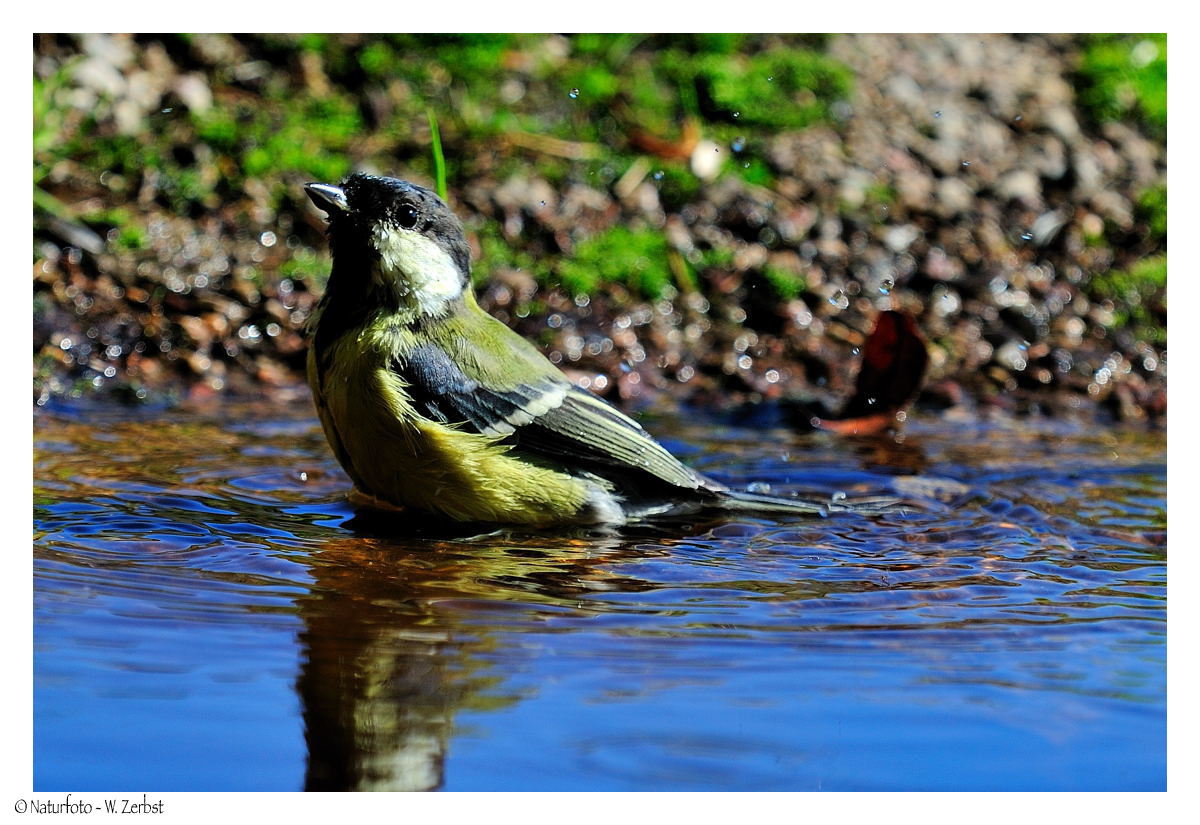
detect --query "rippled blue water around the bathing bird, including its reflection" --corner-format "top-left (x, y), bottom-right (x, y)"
top-left (34, 399), bottom-right (1166, 791)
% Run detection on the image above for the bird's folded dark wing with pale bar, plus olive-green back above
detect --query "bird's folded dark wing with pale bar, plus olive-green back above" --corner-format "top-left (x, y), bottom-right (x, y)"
top-left (392, 311), bottom-right (715, 489)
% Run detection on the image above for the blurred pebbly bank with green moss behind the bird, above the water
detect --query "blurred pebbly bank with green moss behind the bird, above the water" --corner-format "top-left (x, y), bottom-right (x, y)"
top-left (34, 35), bottom-right (1166, 420)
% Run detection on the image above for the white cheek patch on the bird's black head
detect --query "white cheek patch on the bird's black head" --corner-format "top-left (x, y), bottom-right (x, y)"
top-left (371, 225), bottom-right (463, 315)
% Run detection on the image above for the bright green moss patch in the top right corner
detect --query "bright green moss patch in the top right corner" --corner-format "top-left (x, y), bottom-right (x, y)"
top-left (1078, 34), bottom-right (1166, 140)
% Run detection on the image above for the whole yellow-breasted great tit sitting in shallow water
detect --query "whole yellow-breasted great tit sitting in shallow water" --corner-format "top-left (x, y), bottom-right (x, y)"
top-left (305, 174), bottom-right (883, 526)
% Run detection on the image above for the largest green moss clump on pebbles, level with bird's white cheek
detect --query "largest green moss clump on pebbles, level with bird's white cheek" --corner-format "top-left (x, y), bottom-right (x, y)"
top-left (558, 225), bottom-right (673, 297)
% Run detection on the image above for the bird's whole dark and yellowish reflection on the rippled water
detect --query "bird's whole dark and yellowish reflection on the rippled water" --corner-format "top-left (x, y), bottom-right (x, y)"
top-left (298, 518), bottom-right (696, 790)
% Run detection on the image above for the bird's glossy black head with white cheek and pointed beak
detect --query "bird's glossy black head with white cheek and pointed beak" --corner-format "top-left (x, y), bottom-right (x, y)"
top-left (305, 174), bottom-right (470, 317)
